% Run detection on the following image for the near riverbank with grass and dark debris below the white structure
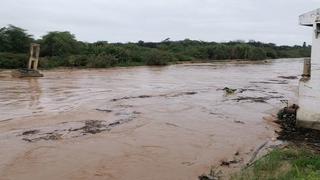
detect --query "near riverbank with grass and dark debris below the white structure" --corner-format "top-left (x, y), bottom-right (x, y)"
top-left (232, 105), bottom-right (320, 180)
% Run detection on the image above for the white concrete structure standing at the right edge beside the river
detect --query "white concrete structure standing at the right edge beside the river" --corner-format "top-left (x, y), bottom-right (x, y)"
top-left (297, 9), bottom-right (320, 130)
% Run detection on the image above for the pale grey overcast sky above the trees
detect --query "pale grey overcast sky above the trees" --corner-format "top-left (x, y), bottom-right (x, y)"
top-left (0, 0), bottom-right (320, 45)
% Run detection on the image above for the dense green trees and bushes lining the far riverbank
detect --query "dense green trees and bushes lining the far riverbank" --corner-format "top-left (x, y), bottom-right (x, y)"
top-left (0, 25), bottom-right (311, 68)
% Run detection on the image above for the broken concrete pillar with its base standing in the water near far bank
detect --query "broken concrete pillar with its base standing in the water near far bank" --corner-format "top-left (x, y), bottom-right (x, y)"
top-left (12, 43), bottom-right (43, 78)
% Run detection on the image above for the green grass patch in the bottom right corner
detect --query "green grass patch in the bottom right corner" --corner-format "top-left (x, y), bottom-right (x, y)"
top-left (232, 147), bottom-right (320, 180)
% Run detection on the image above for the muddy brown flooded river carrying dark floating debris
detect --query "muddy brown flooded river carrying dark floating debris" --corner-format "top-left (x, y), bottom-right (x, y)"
top-left (0, 59), bottom-right (303, 180)
